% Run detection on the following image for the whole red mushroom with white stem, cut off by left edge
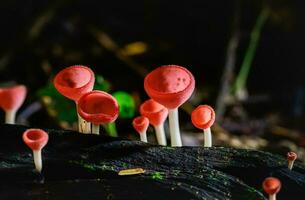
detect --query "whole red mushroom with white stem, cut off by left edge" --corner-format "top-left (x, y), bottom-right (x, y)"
top-left (0, 85), bottom-right (27, 124)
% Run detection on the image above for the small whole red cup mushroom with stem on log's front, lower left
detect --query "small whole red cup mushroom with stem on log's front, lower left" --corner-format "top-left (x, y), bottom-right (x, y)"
top-left (22, 129), bottom-right (49, 173)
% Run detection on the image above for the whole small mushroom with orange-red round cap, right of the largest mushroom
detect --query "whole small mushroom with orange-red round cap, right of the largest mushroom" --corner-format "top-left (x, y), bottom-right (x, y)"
top-left (192, 105), bottom-right (215, 147)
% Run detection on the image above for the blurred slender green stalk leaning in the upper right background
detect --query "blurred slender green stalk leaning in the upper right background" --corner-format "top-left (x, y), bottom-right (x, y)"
top-left (233, 8), bottom-right (269, 97)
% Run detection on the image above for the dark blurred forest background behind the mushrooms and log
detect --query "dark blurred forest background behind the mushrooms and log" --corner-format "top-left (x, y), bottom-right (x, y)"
top-left (0, 0), bottom-right (305, 161)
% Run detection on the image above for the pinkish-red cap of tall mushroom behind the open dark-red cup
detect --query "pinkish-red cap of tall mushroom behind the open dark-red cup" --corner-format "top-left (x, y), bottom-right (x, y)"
top-left (53, 65), bottom-right (95, 101)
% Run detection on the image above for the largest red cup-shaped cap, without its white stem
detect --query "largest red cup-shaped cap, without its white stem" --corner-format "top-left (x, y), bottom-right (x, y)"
top-left (144, 65), bottom-right (195, 109)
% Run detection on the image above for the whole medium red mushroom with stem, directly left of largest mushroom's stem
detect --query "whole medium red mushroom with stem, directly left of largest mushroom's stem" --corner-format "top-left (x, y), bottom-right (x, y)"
top-left (140, 99), bottom-right (168, 146)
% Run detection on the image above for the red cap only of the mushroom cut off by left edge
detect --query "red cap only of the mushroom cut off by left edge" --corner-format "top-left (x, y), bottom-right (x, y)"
top-left (0, 85), bottom-right (27, 111)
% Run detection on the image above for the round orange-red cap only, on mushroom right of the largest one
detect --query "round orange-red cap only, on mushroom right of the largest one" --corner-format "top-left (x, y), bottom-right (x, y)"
top-left (192, 105), bottom-right (215, 129)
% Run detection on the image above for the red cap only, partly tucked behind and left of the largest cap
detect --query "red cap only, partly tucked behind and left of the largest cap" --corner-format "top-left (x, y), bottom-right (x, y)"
top-left (140, 99), bottom-right (168, 126)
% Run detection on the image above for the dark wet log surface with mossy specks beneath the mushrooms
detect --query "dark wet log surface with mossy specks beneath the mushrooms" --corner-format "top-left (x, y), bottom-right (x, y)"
top-left (0, 125), bottom-right (305, 200)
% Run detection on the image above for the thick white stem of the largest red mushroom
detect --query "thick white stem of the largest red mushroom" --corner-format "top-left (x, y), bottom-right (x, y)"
top-left (168, 108), bottom-right (182, 147)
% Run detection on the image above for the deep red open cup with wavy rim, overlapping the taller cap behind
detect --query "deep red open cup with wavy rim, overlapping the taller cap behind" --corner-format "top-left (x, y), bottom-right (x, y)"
top-left (77, 91), bottom-right (119, 125)
